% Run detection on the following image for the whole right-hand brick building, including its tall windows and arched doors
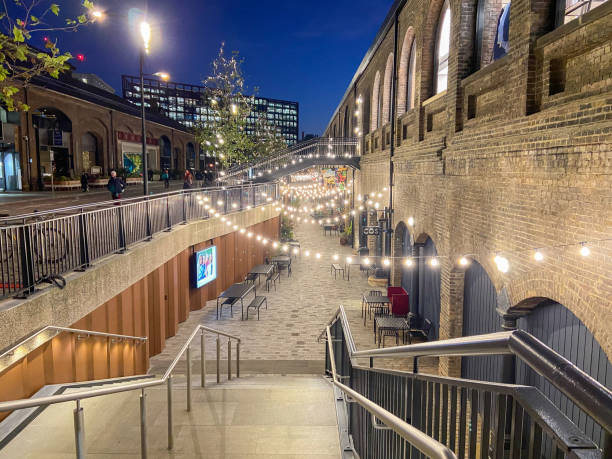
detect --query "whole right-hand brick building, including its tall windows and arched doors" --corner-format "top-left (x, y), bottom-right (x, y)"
top-left (325, 0), bottom-right (612, 448)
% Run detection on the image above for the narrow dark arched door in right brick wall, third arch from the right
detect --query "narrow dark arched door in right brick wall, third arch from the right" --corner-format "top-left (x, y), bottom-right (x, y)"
top-left (417, 235), bottom-right (441, 340)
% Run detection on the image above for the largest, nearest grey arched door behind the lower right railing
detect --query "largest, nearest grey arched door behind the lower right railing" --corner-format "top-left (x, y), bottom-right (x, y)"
top-left (516, 302), bottom-right (612, 446)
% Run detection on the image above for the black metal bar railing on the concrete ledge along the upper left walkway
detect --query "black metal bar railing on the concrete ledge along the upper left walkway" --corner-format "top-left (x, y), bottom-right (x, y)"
top-left (0, 183), bottom-right (278, 299)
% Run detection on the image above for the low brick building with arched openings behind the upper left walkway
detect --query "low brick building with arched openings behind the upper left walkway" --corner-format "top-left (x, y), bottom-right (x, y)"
top-left (7, 74), bottom-right (199, 191)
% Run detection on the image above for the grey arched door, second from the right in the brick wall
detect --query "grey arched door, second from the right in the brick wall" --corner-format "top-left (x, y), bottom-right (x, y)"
top-left (461, 261), bottom-right (503, 382)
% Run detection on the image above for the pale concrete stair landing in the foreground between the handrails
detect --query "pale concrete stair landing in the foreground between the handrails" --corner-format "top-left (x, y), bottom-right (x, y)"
top-left (0, 375), bottom-right (341, 459)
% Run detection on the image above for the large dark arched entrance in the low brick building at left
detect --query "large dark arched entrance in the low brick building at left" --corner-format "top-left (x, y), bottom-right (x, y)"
top-left (32, 107), bottom-right (74, 188)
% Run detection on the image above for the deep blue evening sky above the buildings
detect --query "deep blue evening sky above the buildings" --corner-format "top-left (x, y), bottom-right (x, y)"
top-left (52, 0), bottom-right (392, 135)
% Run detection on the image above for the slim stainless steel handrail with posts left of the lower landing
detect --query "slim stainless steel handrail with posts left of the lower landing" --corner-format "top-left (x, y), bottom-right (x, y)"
top-left (0, 325), bottom-right (240, 458)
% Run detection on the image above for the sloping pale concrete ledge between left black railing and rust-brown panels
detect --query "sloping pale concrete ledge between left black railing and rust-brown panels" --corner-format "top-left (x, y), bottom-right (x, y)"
top-left (0, 204), bottom-right (279, 349)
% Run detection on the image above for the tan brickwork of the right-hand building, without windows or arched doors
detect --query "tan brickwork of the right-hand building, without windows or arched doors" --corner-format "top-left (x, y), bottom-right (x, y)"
top-left (330, 0), bottom-right (612, 375)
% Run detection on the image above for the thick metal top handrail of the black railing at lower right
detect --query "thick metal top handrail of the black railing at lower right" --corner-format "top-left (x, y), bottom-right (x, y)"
top-left (326, 306), bottom-right (612, 432)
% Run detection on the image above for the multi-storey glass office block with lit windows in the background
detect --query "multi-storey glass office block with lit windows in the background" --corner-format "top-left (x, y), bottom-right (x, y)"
top-left (121, 75), bottom-right (299, 145)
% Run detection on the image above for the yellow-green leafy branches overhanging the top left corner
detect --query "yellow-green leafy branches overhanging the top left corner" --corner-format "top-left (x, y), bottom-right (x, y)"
top-left (0, 0), bottom-right (95, 111)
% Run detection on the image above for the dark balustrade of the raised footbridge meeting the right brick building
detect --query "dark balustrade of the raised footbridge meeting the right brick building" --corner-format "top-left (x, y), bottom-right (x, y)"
top-left (219, 137), bottom-right (360, 182)
